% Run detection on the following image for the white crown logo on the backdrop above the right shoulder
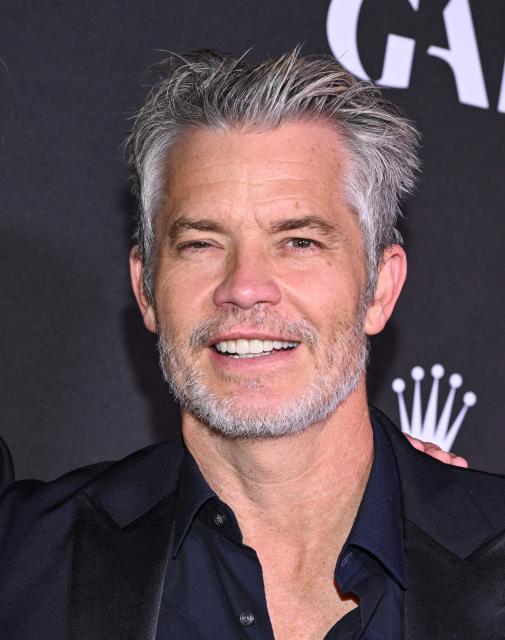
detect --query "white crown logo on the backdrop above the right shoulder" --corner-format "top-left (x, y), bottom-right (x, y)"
top-left (392, 364), bottom-right (477, 451)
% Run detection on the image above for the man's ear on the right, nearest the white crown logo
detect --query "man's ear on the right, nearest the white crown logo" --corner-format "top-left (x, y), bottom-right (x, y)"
top-left (365, 244), bottom-right (407, 336)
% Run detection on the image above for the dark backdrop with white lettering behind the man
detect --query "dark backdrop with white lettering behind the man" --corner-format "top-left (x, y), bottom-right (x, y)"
top-left (0, 0), bottom-right (505, 478)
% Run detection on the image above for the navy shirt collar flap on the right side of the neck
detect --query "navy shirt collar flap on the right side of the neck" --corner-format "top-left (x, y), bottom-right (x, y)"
top-left (341, 417), bottom-right (405, 587)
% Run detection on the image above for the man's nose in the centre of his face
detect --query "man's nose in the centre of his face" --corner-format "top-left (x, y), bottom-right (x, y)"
top-left (214, 250), bottom-right (281, 309)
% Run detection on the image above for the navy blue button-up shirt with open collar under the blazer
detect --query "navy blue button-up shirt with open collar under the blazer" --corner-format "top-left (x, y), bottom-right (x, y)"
top-left (156, 423), bottom-right (405, 640)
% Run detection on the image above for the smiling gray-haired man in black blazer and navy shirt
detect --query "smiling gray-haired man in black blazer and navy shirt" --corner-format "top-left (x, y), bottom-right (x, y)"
top-left (0, 50), bottom-right (498, 640)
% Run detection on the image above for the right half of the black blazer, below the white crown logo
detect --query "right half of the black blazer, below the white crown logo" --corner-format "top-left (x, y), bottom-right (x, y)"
top-left (372, 410), bottom-right (505, 640)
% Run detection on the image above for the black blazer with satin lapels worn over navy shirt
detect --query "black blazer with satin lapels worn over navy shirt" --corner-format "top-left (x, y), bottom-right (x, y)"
top-left (0, 409), bottom-right (505, 640)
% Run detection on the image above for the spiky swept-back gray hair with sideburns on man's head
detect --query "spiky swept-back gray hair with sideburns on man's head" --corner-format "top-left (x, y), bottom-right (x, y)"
top-left (126, 47), bottom-right (419, 302)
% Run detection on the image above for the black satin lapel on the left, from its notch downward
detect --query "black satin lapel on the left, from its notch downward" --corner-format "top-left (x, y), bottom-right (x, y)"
top-left (70, 495), bottom-right (173, 640)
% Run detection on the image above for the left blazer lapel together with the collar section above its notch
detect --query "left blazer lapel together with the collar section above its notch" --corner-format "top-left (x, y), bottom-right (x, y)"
top-left (70, 445), bottom-right (182, 640)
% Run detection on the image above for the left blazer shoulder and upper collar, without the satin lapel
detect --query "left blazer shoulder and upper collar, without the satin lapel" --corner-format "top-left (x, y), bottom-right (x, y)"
top-left (0, 443), bottom-right (183, 639)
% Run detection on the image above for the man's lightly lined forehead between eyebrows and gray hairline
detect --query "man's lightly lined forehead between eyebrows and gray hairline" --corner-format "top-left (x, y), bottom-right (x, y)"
top-left (161, 117), bottom-right (348, 208)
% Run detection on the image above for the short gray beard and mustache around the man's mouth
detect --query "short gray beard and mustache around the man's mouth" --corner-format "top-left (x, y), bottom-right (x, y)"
top-left (158, 300), bottom-right (368, 438)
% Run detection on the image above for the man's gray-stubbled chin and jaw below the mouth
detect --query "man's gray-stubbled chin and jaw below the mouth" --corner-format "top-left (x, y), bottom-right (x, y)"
top-left (158, 322), bottom-right (367, 438)
